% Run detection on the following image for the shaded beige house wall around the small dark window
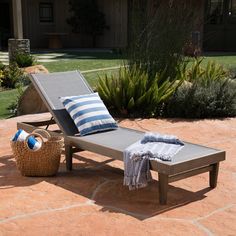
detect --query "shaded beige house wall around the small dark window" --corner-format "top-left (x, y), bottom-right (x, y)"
top-left (22, 0), bottom-right (128, 48)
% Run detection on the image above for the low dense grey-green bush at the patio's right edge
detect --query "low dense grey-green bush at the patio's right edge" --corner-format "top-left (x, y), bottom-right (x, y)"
top-left (164, 79), bottom-right (236, 118)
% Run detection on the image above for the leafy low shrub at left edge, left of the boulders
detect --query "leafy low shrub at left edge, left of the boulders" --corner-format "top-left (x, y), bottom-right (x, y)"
top-left (1, 63), bottom-right (28, 88)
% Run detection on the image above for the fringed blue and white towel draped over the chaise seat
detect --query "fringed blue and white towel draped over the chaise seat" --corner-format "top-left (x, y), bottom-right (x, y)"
top-left (124, 133), bottom-right (184, 190)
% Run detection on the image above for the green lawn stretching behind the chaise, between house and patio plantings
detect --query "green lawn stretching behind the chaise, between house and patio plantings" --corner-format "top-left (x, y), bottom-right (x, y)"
top-left (0, 52), bottom-right (236, 119)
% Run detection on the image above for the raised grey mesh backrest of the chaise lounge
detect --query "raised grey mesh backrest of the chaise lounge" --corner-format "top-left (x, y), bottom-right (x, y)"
top-left (30, 71), bottom-right (93, 135)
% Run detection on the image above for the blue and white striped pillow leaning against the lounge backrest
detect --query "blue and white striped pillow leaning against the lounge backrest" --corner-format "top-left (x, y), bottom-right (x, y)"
top-left (60, 93), bottom-right (118, 136)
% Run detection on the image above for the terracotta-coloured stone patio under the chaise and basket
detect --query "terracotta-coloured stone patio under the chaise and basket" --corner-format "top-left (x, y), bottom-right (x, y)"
top-left (0, 113), bottom-right (236, 236)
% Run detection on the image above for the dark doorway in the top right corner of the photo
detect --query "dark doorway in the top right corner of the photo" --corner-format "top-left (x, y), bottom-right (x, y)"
top-left (203, 0), bottom-right (236, 51)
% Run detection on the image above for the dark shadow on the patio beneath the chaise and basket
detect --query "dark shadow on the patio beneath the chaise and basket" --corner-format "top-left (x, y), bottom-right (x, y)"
top-left (0, 152), bottom-right (211, 220)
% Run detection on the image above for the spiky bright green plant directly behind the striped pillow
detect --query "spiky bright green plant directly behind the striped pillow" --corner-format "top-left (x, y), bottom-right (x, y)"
top-left (97, 66), bottom-right (180, 117)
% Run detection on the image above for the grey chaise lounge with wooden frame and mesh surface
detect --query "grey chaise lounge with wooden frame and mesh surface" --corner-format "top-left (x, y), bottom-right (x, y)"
top-left (18, 71), bottom-right (225, 204)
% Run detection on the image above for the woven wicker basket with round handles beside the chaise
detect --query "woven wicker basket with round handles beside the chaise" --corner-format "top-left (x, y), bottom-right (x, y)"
top-left (11, 129), bottom-right (63, 176)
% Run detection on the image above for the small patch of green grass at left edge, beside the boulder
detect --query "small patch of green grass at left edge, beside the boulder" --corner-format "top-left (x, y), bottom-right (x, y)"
top-left (0, 89), bottom-right (17, 119)
